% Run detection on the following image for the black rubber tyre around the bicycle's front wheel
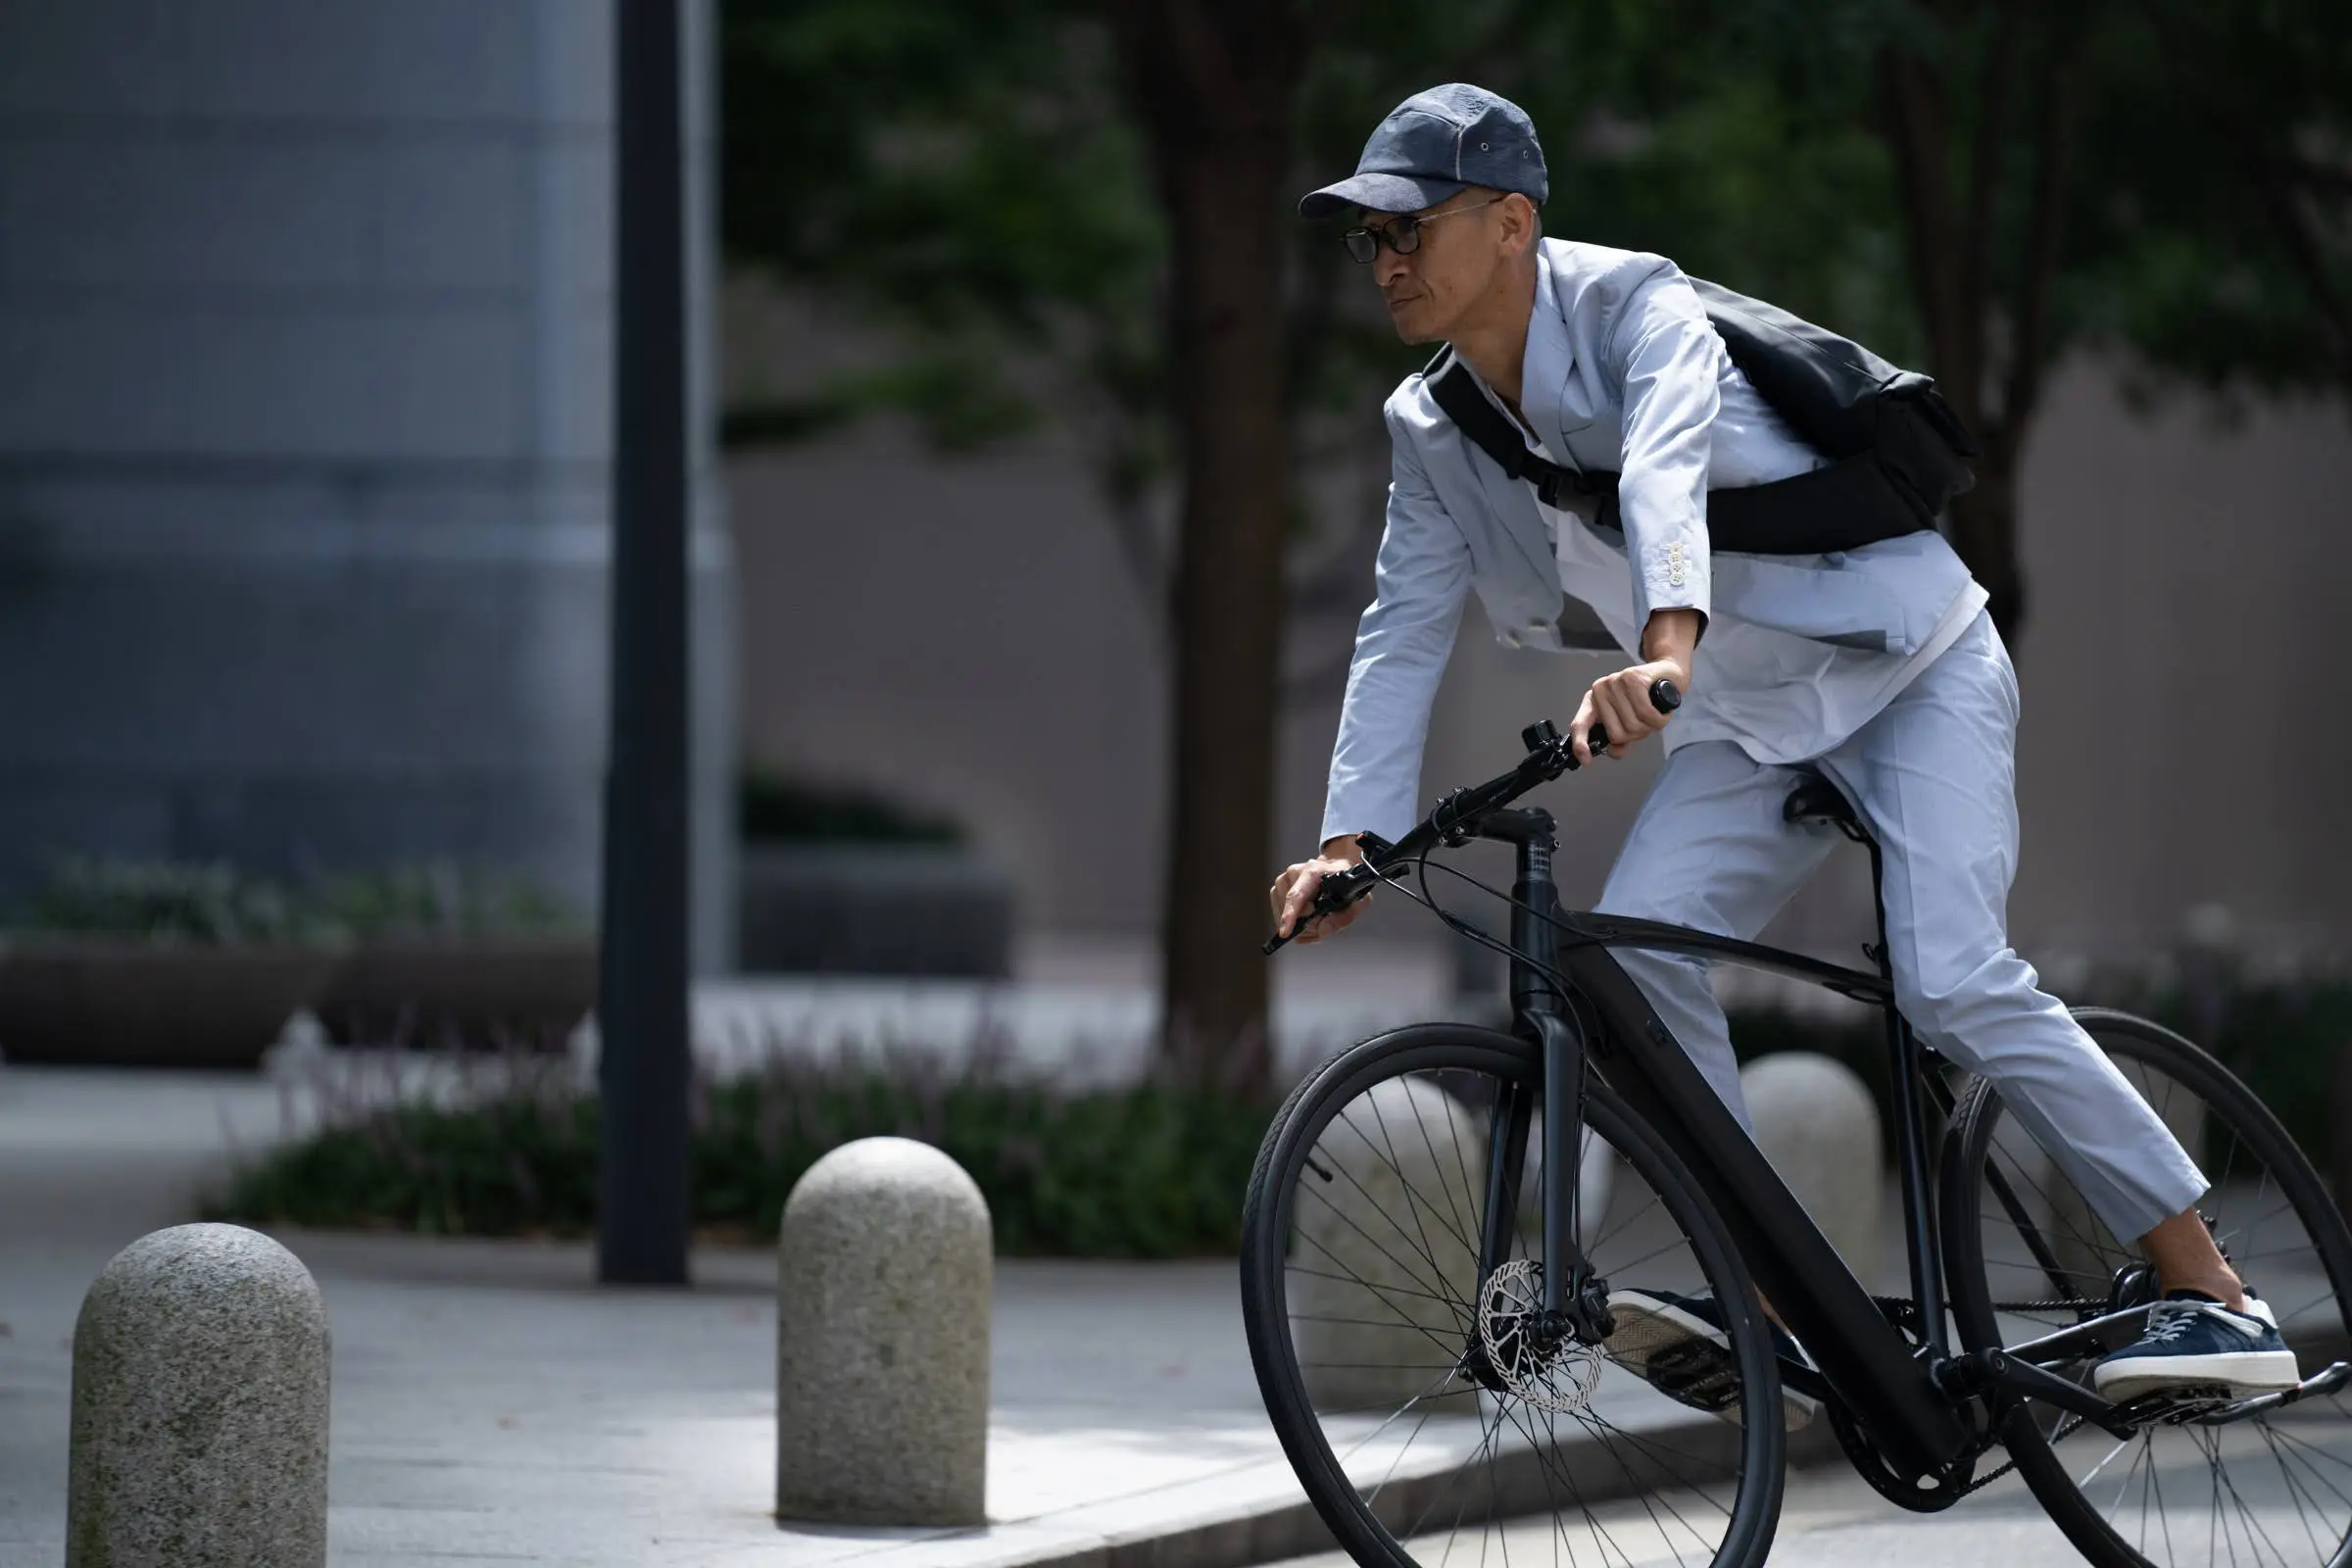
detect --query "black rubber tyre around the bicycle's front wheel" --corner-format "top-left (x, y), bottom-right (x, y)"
top-left (1240, 1025), bottom-right (1786, 1568)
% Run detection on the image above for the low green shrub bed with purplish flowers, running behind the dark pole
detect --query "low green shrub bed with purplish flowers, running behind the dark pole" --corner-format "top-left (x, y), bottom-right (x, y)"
top-left (212, 1062), bottom-right (1270, 1257)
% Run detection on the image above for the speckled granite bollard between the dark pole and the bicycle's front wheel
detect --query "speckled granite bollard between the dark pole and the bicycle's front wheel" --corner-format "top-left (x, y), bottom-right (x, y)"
top-left (776, 1138), bottom-right (995, 1526)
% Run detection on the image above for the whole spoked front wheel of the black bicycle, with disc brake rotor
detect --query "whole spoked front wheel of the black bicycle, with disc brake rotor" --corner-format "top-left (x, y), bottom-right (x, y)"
top-left (1242, 1025), bottom-right (1786, 1568)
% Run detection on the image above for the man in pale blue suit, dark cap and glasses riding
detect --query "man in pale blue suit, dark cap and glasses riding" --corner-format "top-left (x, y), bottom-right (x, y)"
top-left (1270, 84), bottom-right (2298, 1401)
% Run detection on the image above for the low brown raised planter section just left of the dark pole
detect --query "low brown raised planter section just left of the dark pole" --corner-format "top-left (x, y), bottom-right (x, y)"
top-left (311, 936), bottom-right (598, 1049)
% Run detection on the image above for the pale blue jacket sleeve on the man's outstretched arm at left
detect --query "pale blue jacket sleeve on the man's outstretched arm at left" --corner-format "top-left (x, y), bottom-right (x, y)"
top-left (1315, 409), bottom-right (1470, 844)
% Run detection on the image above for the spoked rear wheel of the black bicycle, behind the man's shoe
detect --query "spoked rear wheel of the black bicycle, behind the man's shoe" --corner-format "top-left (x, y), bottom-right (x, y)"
top-left (1942, 1008), bottom-right (2352, 1568)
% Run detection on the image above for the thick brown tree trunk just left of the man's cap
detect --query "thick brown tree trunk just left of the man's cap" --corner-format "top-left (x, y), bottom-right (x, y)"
top-left (1124, 0), bottom-right (1305, 1089)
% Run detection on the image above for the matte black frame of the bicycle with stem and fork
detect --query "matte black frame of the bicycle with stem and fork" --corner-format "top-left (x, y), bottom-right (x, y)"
top-left (1477, 808), bottom-right (1976, 1476)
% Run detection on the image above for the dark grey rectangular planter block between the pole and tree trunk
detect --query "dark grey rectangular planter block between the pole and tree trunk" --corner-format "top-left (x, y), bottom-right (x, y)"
top-left (736, 844), bottom-right (1013, 978)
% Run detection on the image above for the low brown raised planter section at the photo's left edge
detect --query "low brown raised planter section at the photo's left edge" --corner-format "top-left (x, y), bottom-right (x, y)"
top-left (0, 936), bottom-right (343, 1067)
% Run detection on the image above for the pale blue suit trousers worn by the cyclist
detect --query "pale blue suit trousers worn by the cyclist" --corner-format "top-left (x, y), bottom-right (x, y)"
top-left (1599, 613), bottom-right (2206, 1242)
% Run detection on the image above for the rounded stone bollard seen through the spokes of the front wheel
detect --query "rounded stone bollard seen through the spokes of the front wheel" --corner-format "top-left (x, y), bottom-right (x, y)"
top-left (1292, 1079), bottom-right (1487, 1415)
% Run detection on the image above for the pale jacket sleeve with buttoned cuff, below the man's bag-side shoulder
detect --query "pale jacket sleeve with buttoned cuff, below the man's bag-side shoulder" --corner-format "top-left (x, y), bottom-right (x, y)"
top-left (1604, 259), bottom-right (1724, 630)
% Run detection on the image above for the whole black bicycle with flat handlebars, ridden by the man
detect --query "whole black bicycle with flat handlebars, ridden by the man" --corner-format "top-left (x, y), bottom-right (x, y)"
top-left (1242, 686), bottom-right (2352, 1568)
